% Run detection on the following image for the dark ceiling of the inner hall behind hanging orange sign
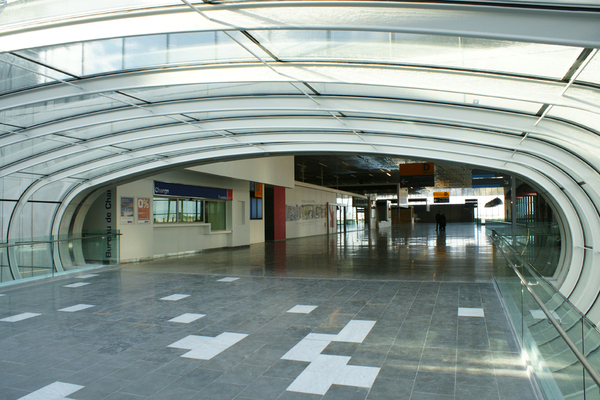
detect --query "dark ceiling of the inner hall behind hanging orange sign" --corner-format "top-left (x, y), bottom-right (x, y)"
top-left (295, 154), bottom-right (494, 194)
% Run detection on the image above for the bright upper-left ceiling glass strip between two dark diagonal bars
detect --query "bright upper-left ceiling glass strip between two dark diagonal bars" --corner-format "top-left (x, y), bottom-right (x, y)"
top-left (16, 32), bottom-right (256, 76)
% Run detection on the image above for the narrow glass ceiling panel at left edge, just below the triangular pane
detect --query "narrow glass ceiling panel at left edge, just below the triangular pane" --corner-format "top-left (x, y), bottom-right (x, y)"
top-left (0, 92), bottom-right (140, 127)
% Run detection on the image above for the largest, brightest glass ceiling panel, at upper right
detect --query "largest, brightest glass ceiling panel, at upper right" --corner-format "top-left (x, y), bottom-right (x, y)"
top-left (249, 30), bottom-right (582, 79)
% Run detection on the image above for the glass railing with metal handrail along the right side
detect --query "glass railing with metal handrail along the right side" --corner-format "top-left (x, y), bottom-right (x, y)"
top-left (490, 230), bottom-right (600, 400)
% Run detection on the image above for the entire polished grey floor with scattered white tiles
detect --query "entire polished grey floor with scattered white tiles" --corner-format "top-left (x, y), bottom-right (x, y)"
top-left (0, 225), bottom-right (535, 400)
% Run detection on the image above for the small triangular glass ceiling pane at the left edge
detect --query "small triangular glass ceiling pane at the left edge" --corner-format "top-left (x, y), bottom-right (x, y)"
top-left (0, 53), bottom-right (71, 94)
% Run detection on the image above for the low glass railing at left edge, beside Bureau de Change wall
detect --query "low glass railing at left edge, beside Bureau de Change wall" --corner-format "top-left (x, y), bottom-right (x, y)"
top-left (0, 232), bottom-right (120, 283)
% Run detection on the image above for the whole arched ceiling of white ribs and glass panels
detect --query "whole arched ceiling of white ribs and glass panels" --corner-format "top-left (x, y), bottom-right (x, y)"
top-left (0, 0), bottom-right (600, 321)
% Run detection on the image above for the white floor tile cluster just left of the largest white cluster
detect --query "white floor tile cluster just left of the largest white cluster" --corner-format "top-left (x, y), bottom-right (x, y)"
top-left (167, 332), bottom-right (248, 360)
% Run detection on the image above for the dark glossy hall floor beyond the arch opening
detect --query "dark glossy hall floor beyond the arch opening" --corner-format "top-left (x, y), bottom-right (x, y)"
top-left (127, 224), bottom-right (505, 282)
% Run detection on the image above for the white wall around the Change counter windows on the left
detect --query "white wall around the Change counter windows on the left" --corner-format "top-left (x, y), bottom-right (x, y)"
top-left (86, 157), bottom-right (370, 262)
